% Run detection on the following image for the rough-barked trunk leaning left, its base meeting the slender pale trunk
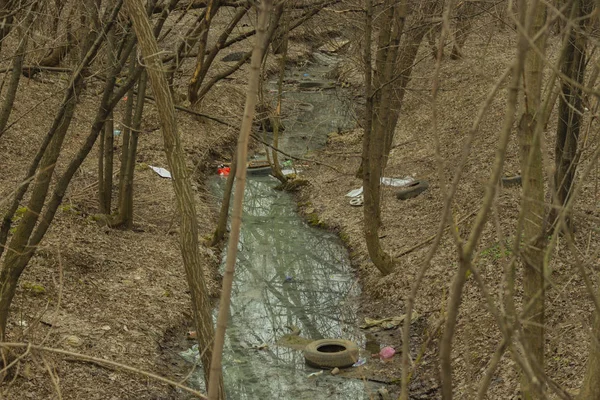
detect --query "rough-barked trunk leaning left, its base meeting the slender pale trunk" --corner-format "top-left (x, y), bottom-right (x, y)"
top-left (125, 0), bottom-right (224, 399)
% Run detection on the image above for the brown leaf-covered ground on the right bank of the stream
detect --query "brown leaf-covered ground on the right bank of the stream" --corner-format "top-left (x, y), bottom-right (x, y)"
top-left (300, 13), bottom-right (600, 399)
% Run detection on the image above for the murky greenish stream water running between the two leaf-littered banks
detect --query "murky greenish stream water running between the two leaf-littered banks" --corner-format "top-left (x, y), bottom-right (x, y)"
top-left (182, 51), bottom-right (378, 400)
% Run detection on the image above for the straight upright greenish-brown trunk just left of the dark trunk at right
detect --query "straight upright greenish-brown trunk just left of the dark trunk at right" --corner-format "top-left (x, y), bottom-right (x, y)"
top-left (518, 0), bottom-right (546, 399)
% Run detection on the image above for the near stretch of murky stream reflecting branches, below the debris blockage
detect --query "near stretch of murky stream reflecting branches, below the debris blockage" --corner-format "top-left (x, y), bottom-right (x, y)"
top-left (202, 177), bottom-right (376, 399)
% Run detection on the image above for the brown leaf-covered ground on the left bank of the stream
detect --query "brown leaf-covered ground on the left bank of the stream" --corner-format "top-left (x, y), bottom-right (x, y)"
top-left (0, 9), bottom-right (310, 400)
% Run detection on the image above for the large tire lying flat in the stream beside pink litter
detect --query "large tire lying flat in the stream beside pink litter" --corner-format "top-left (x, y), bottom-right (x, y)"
top-left (304, 339), bottom-right (358, 369)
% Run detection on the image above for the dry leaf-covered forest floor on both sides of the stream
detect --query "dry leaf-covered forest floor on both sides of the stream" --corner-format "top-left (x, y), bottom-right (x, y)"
top-left (0, 5), bottom-right (600, 399)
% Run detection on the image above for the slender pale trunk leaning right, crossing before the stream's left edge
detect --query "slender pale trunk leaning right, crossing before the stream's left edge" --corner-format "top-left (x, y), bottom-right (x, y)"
top-left (208, 0), bottom-right (271, 400)
